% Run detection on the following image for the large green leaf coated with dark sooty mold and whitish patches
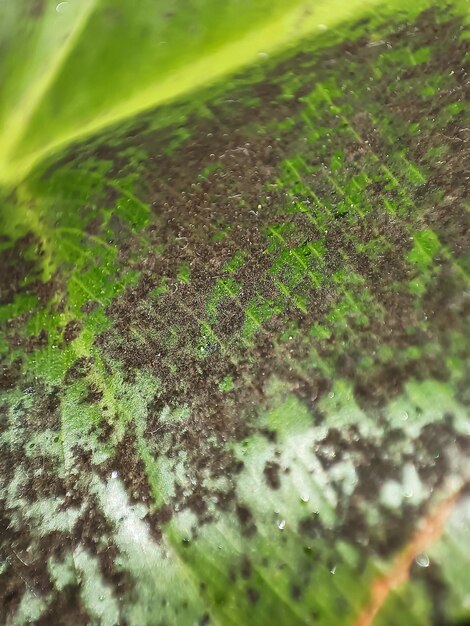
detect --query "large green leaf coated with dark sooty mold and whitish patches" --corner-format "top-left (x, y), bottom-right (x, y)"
top-left (0, 2), bottom-right (470, 626)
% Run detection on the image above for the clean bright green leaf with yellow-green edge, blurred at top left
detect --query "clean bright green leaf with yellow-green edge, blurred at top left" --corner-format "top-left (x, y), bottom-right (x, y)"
top-left (0, 0), bottom-right (384, 184)
